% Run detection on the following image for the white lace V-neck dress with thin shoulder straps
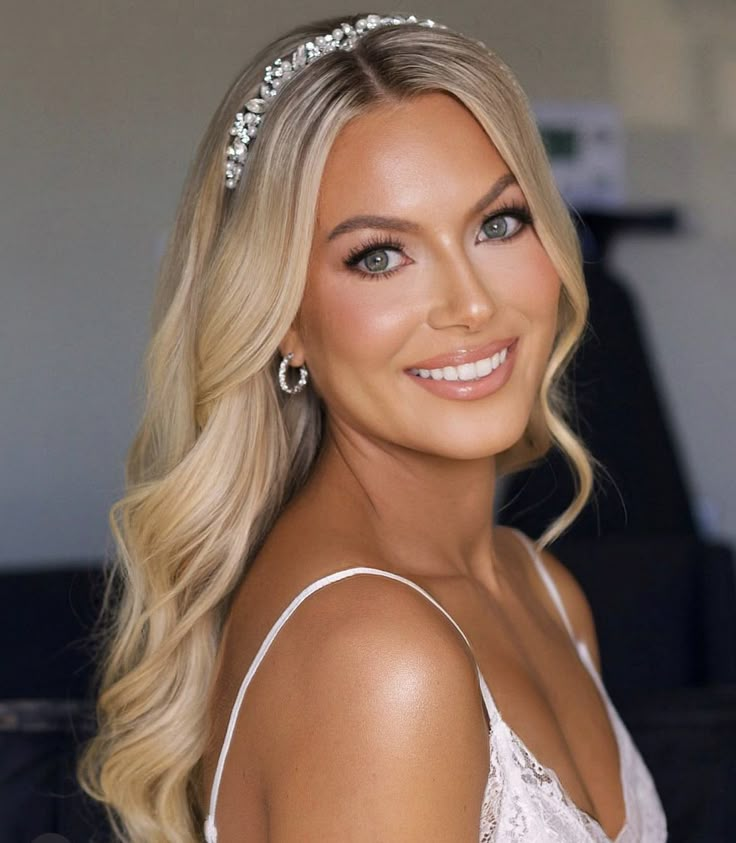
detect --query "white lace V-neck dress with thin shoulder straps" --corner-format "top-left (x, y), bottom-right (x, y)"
top-left (204, 530), bottom-right (667, 843)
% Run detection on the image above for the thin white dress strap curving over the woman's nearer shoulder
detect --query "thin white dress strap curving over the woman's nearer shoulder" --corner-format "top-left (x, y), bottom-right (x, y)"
top-left (204, 566), bottom-right (493, 843)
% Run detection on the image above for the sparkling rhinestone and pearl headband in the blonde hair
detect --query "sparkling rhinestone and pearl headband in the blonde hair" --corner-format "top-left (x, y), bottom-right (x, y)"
top-left (225, 15), bottom-right (447, 190)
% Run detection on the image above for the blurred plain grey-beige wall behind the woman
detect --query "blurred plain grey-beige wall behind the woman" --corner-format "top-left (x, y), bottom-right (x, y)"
top-left (0, 0), bottom-right (736, 566)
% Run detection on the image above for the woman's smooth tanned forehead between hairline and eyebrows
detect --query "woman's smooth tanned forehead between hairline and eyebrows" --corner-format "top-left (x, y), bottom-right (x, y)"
top-left (318, 92), bottom-right (508, 228)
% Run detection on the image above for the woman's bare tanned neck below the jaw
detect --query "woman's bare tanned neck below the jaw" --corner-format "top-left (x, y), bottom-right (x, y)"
top-left (300, 422), bottom-right (500, 593)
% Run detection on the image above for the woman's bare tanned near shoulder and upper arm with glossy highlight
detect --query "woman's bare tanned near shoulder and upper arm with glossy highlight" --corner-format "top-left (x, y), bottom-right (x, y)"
top-left (265, 574), bottom-right (489, 843)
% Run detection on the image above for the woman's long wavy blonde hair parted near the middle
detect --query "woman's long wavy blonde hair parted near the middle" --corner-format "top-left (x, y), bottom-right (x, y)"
top-left (78, 9), bottom-right (594, 843)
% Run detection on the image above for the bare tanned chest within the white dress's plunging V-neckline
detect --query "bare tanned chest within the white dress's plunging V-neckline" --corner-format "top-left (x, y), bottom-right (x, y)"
top-left (420, 572), bottom-right (626, 840)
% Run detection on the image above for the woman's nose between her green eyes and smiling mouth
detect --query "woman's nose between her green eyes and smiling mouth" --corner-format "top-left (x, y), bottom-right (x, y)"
top-left (428, 244), bottom-right (495, 331)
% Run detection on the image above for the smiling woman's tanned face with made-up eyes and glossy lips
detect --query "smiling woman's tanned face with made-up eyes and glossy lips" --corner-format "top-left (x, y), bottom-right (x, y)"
top-left (281, 93), bottom-right (560, 459)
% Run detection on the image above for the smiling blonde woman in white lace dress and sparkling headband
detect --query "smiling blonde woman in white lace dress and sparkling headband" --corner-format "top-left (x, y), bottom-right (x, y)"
top-left (80, 15), bottom-right (665, 843)
